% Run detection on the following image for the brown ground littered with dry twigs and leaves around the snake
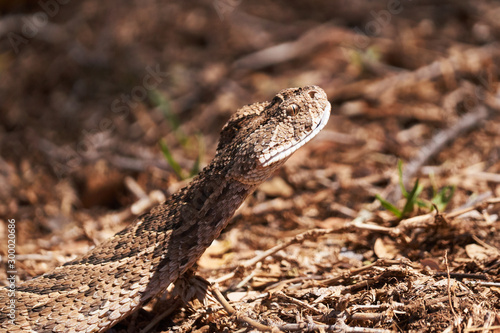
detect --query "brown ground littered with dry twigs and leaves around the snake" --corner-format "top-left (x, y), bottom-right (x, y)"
top-left (0, 0), bottom-right (500, 332)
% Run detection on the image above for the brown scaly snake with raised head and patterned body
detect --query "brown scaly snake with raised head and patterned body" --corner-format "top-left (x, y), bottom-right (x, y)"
top-left (0, 86), bottom-right (330, 332)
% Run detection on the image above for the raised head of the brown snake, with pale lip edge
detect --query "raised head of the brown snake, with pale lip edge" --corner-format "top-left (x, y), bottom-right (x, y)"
top-left (216, 86), bottom-right (331, 184)
